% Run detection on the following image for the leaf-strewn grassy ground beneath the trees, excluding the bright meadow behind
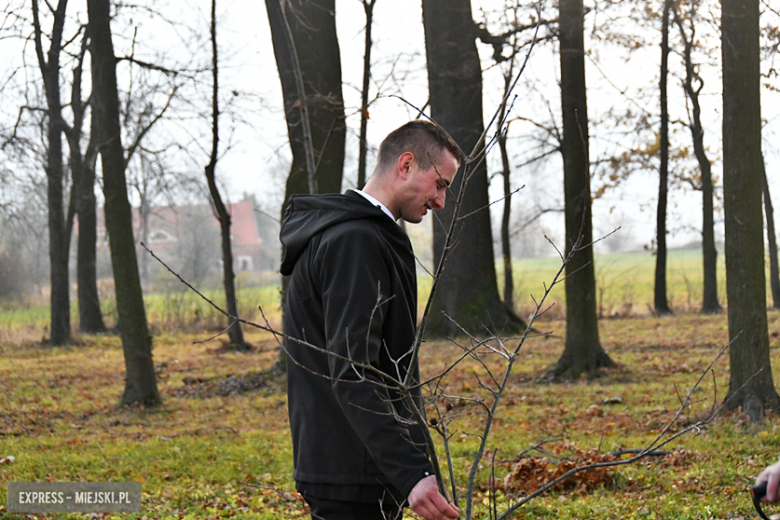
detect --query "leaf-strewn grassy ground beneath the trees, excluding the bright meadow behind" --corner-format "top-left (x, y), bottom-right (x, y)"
top-left (0, 311), bottom-right (780, 520)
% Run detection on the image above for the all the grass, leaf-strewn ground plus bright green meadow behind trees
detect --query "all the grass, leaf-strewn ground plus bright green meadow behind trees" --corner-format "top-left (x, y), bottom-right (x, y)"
top-left (0, 251), bottom-right (780, 520)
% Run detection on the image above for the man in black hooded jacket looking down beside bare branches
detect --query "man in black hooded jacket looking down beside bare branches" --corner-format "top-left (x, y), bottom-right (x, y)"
top-left (280, 121), bottom-right (462, 520)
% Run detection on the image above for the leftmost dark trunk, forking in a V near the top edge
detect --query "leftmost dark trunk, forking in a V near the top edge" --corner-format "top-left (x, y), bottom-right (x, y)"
top-left (32, 0), bottom-right (71, 345)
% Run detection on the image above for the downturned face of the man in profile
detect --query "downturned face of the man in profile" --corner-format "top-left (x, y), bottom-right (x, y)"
top-left (400, 150), bottom-right (458, 224)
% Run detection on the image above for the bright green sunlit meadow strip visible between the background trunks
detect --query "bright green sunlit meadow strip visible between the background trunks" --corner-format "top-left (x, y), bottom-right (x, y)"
top-left (0, 250), bottom-right (748, 334)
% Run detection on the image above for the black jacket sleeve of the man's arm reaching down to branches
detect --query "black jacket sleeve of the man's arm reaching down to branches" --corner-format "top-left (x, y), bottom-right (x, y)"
top-left (312, 222), bottom-right (433, 497)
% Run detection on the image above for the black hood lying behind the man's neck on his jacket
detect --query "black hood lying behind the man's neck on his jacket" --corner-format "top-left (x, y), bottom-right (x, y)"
top-left (279, 191), bottom-right (395, 276)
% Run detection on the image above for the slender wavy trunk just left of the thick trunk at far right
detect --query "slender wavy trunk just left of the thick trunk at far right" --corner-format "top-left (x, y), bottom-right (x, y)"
top-left (672, 2), bottom-right (723, 314)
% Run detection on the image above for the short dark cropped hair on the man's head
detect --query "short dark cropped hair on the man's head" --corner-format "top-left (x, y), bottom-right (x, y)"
top-left (377, 119), bottom-right (463, 170)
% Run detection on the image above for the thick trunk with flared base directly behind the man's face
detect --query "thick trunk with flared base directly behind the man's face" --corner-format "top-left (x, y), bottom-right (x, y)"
top-left (423, 0), bottom-right (523, 337)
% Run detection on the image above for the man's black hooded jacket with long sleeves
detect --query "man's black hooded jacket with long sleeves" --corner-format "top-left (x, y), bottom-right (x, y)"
top-left (280, 191), bottom-right (433, 502)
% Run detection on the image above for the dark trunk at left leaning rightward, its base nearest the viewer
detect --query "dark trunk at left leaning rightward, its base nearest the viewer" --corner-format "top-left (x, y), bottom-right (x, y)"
top-left (87, 0), bottom-right (160, 405)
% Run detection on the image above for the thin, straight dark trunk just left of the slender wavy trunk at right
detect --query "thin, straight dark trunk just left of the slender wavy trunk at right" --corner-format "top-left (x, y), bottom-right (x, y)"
top-left (654, 0), bottom-right (672, 314)
